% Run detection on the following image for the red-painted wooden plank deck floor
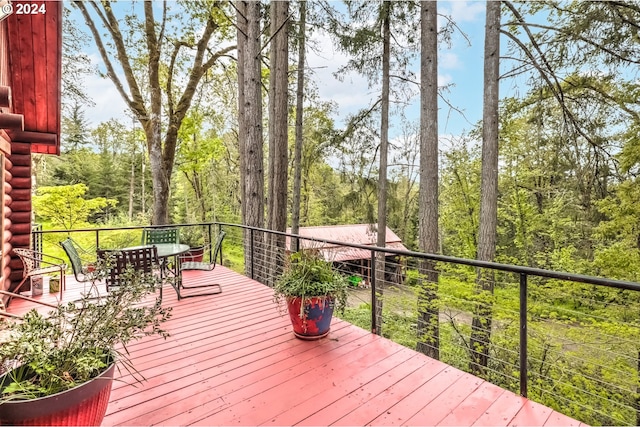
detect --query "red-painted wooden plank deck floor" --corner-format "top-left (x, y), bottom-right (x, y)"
top-left (10, 266), bottom-right (580, 426)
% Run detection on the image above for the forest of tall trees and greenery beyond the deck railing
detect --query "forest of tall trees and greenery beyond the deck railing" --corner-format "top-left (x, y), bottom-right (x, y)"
top-left (27, 1), bottom-right (640, 424)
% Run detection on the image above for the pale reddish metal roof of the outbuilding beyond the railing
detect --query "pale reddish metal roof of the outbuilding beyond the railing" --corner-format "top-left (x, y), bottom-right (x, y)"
top-left (287, 224), bottom-right (407, 261)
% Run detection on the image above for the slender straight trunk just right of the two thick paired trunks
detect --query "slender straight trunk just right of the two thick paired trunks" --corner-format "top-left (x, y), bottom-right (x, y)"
top-left (291, 0), bottom-right (307, 254)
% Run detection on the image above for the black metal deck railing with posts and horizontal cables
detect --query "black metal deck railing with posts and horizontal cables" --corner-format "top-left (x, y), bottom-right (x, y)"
top-left (34, 223), bottom-right (640, 425)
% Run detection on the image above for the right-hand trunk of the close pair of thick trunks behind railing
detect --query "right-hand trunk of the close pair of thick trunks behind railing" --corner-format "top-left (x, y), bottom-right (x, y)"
top-left (268, 0), bottom-right (289, 288)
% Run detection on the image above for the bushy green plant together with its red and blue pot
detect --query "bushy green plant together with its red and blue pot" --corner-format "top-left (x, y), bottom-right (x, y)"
top-left (274, 252), bottom-right (349, 340)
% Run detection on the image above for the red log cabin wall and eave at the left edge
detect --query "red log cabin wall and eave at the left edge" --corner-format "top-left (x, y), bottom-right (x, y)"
top-left (0, 0), bottom-right (64, 300)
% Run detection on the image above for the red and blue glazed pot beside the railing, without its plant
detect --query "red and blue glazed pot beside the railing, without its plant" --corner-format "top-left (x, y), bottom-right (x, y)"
top-left (287, 297), bottom-right (334, 340)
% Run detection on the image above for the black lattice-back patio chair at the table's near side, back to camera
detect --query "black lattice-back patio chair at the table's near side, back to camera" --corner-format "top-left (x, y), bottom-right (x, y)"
top-left (97, 246), bottom-right (163, 300)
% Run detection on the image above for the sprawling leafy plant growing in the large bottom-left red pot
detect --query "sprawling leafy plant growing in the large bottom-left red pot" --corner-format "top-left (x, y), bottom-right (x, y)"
top-left (0, 262), bottom-right (171, 403)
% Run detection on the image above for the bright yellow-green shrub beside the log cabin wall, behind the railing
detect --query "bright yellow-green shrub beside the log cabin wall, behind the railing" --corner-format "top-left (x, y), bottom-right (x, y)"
top-left (33, 184), bottom-right (116, 230)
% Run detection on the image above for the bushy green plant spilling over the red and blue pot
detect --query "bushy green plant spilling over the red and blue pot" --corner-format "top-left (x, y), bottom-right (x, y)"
top-left (274, 252), bottom-right (349, 313)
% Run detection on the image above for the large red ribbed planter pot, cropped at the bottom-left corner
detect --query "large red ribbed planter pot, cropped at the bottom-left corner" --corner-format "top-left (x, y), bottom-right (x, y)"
top-left (0, 363), bottom-right (115, 426)
